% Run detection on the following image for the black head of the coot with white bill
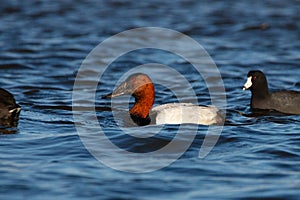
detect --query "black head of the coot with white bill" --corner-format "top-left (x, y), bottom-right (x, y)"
top-left (243, 70), bottom-right (268, 94)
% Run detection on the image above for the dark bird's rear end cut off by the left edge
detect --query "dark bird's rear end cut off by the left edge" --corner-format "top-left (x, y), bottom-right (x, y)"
top-left (0, 88), bottom-right (21, 127)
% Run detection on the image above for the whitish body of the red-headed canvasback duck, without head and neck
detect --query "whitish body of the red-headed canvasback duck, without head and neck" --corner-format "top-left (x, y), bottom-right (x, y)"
top-left (151, 103), bottom-right (224, 125)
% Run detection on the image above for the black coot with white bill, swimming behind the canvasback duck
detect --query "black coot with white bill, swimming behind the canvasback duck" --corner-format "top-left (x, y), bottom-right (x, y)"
top-left (243, 70), bottom-right (300, 114)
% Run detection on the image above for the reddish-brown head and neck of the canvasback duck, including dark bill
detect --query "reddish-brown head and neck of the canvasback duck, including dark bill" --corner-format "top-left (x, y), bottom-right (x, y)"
top-left (103, 73), bottom-right (155, 125)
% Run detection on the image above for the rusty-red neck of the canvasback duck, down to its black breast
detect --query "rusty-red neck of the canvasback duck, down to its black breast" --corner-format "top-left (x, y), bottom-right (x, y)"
top-left (129, 86), bottom-right (155, 126)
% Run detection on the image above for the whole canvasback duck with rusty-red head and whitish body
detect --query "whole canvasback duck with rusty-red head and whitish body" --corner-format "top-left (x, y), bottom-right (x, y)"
top-left (103, 73), bottom-right (224, 126)
